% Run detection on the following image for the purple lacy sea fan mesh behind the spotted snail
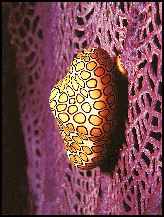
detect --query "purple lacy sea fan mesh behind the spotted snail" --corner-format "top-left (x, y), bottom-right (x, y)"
top-left (4, 2), bottom-right (162, 215)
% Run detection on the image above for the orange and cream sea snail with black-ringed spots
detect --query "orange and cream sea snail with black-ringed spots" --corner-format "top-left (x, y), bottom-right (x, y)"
top-left (49, 48), bottom-right (125, 169)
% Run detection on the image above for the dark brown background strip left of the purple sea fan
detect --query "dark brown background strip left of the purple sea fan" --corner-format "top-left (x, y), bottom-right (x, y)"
top-left (1, 3), bottom-right (28, 215)
